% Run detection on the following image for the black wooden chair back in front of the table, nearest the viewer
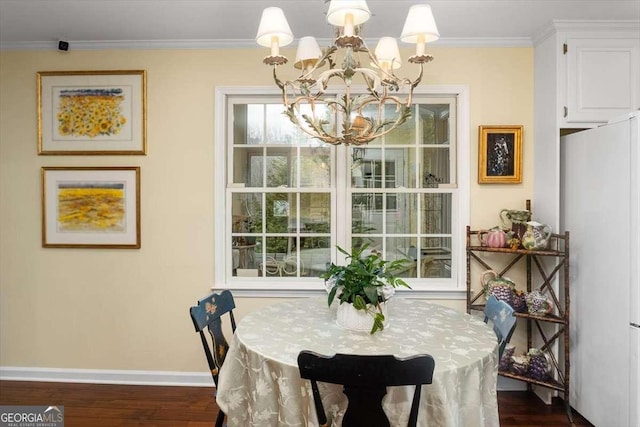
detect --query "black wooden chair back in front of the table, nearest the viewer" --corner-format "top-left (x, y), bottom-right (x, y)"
top-left (298, 350), bottom-right (435, 427)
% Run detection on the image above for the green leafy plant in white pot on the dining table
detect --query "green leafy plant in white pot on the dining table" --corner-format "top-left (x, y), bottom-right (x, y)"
top-left (320, 243), bottom-right (410, 334)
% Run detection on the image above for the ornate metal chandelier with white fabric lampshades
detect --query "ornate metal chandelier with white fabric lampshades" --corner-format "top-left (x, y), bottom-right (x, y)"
top-left (256, 0), bottom-right (440, 145)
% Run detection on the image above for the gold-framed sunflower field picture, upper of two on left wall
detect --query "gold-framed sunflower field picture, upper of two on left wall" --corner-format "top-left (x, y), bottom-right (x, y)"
top-left (37, 70), bottom-right (147, 155)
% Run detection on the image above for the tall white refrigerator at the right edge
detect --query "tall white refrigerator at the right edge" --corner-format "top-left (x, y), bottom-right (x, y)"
top-left (560, 112), bottom-right (640, 427)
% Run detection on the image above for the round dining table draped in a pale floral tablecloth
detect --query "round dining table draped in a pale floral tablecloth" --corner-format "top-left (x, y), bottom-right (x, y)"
top-left (216, 294), bottom-right (500, 427)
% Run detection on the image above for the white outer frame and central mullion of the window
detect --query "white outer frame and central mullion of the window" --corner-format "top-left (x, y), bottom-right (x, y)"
top-left (212, 85), bottom-right (471, 299)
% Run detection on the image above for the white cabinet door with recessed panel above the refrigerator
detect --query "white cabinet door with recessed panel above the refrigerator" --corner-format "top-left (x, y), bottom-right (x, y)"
top-left (565, 38), bottom-right (640, 123)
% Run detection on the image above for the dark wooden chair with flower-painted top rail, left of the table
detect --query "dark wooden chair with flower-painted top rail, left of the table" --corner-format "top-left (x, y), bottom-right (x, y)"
top-left (189, 291), bottom-right (236, 427)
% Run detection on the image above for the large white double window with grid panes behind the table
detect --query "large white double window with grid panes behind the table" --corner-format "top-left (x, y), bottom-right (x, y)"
top-left (215, 87), bottom-right (469, 292)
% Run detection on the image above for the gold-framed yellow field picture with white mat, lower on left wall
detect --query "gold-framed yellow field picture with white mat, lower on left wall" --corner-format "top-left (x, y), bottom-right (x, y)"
top-left (41, 167), bottom-right (140, 249)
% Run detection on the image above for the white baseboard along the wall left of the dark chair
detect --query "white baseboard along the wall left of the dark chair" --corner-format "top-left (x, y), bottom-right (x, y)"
top-left (0, 366), bottom-right (213, 387)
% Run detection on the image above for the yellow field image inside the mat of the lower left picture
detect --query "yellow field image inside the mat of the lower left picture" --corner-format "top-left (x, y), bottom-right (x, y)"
top-left (58, 183), bottom-right (126, 233)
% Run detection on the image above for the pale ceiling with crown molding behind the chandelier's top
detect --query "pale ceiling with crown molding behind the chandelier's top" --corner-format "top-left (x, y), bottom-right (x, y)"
top-left (0, 0), bottom-right (640, 49)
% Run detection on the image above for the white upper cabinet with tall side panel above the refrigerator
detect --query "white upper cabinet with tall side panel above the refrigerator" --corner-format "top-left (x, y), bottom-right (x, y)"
top-left (533, 20), bottom-right (640, 229)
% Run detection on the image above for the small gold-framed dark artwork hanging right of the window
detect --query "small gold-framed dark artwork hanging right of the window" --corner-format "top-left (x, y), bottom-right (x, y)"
top-left (478, 126), bottom-right (522, 184)
